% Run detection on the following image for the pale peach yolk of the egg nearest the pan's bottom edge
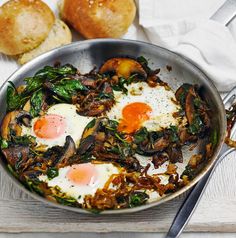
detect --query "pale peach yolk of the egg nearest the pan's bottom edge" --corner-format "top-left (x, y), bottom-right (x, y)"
top-left (66, 163), bottom-right (98, 186)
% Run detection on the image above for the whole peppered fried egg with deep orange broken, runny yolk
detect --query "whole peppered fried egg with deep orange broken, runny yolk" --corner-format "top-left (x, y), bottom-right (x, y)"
top-left (107, 82), bottom-right (183, 133)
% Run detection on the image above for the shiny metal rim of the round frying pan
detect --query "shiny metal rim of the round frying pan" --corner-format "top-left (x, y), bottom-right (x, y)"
top-left (0, 38), bottom-right (226, 215)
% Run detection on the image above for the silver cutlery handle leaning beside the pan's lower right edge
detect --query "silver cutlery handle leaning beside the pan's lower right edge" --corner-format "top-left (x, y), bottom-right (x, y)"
top-left (166, 145), bottom-right (235, 238)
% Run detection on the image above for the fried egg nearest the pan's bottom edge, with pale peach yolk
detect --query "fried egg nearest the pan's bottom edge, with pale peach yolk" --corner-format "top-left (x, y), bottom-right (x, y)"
top-left (39, 163), bottom-right (119, 203)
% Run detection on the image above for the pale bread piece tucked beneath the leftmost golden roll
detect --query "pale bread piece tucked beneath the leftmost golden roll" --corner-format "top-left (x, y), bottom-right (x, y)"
top-left (18, 19), bottom-right (72, 64)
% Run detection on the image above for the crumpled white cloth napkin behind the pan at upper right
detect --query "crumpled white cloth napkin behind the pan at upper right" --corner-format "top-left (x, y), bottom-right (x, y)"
top-left (125, 0), bottom-right (236, 92)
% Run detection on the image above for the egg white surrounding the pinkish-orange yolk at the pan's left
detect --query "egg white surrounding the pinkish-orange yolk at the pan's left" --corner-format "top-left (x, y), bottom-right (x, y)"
top-left (21, 103), bottom-right (93, 148)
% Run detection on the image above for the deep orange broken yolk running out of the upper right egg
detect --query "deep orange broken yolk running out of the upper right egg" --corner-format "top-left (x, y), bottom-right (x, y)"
top-left (118, 102), bottom-right (152, 134)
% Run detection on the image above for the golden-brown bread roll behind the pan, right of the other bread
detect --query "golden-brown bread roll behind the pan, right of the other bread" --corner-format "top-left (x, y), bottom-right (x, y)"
top-left (61, 0), bottom-right (136, 38)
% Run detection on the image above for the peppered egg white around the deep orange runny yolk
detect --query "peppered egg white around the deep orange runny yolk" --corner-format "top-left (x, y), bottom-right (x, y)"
top-left (107, 82), bottom-right (181, 131)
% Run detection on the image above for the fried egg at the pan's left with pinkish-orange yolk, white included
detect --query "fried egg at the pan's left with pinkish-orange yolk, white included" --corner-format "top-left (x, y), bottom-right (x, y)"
top-left (21, 103), bottom-right (93, 148)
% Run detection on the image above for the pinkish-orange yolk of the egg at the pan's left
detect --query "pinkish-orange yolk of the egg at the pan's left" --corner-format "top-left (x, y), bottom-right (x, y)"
top-left (33, 114), bottom-right (66, 139)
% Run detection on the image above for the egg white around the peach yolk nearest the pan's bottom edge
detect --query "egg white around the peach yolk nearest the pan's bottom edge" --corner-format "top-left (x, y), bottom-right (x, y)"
top-left (39, 163), bottom-right (119, 203)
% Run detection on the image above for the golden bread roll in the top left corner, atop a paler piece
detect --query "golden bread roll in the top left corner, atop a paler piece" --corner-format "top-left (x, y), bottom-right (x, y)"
top-left (0, 0), bottom-right (55, 55)
